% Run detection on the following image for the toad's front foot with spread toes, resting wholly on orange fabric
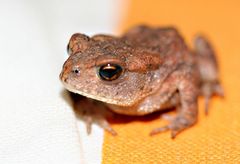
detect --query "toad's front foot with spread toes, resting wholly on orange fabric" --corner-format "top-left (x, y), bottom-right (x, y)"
top-left (150, 114), bottom-right (196, 139)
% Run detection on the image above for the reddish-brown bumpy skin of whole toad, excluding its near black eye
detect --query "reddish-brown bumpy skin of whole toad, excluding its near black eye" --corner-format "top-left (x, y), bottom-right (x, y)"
top-left (60, 26), bottom-right (223, 138)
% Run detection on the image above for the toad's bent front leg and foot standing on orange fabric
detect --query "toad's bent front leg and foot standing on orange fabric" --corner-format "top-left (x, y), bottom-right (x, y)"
top-left (150, 66), bottom-right (198, 138)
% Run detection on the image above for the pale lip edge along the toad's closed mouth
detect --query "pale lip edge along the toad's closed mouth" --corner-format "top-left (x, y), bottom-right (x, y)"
top-left (62, 81), bottom-right (134, 107)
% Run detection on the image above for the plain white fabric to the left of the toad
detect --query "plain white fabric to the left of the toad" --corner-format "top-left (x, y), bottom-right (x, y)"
top-left (0, 0), bottom-right (119, 164)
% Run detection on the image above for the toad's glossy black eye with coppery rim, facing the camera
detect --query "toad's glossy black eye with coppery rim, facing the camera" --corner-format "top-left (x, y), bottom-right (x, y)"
top-left (98, 64), bottom-right (123, 81)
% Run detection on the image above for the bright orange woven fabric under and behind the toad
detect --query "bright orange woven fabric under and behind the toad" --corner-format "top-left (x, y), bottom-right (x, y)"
top-left (102, 0), bottom-right (240, 164)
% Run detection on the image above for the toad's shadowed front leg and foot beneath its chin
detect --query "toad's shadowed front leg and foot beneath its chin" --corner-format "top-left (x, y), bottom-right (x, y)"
top-left (74, 95), bottom-right (117, 136)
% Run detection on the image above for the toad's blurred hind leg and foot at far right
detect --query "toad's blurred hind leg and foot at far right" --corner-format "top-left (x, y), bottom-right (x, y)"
top-left (194, 36), bottom-right (224, 114)
